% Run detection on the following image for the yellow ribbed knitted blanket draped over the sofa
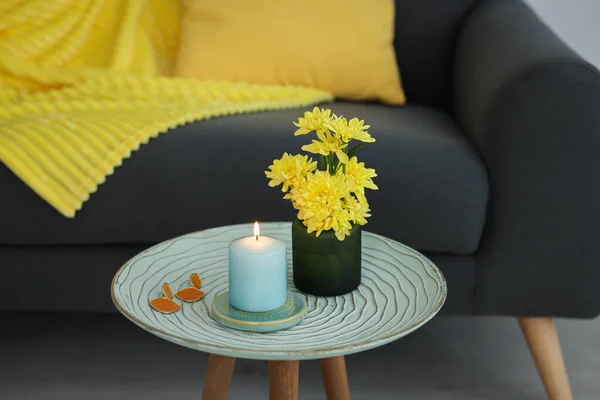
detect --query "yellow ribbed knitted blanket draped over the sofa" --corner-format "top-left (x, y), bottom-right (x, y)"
top-left (0, 0), bottom-right (332, 217)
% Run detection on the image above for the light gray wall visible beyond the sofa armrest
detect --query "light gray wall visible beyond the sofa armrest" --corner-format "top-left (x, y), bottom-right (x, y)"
top-left (526, 0), bottom-right (600, 67)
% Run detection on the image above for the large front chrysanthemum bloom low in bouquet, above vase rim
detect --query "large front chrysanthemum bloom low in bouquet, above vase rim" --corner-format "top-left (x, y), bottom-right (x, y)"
top-left (284, 171), bottom-right (353, 240)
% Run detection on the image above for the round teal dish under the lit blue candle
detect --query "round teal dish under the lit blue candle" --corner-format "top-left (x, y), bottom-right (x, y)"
top-left (212, 291), bottom-right (307, 333)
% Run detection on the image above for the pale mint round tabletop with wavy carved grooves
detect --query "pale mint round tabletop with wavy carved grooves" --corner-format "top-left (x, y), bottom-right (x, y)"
top-left (111, 222), bottom-right (447, 360)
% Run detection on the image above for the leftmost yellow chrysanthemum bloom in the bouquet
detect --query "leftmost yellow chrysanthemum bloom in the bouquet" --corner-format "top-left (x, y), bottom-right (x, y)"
top-left (265, 153), bottom-right (317, 192)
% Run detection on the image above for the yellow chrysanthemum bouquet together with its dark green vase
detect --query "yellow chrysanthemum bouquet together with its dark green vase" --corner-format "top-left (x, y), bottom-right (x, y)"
top-left (265, 107), bottom-right (377, 296)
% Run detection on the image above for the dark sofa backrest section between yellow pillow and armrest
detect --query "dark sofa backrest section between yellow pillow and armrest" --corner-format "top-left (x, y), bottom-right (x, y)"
top-left (394, 0), bottom-right (486, 111)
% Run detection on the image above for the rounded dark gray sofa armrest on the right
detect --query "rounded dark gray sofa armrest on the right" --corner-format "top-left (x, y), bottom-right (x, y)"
top-left (453, 0), bottom-right (600, 317)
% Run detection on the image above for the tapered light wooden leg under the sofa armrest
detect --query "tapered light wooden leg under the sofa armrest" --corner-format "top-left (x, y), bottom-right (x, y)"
top-left (518, 317), bottom-right (573, 400)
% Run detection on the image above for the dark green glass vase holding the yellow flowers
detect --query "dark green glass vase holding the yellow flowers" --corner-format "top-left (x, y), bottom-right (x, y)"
top-left (292, 219), bottom-right (361, 296)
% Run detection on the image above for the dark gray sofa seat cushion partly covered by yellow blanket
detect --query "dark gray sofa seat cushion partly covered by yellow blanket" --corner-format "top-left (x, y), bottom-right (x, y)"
top-left (0, 102), bottom-right (488, 254)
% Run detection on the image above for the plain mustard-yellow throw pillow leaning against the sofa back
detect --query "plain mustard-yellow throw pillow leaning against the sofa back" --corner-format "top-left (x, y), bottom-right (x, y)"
top-left (175, 0), bottom-right (406, 105)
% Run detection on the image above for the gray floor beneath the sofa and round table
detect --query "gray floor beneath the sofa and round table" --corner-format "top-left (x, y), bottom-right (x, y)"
top-left (0, 313), bottom-right (600, 400)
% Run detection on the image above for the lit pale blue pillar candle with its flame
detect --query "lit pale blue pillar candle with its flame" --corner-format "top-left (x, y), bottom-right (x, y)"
top-left (229, 222), bottom-right (287, 312)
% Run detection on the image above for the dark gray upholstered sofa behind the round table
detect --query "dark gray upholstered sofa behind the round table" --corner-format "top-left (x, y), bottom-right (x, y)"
top-left (0, 0), bottom-right (600, 393)
